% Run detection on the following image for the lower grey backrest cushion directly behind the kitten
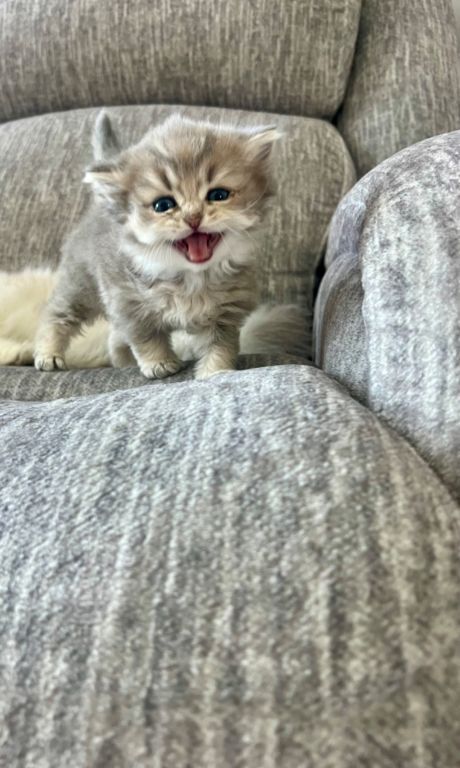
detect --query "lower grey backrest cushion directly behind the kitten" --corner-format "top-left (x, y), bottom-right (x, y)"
top-left (0, 102), bottom-right (355, 307)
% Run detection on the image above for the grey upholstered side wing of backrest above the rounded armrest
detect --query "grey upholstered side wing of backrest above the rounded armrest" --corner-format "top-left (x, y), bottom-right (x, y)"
top-left (338, 0), bottom-right (460, 175)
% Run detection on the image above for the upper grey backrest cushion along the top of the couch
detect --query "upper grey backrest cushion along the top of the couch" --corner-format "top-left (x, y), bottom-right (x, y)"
top-left (0, 0), bottom-right (361, 119)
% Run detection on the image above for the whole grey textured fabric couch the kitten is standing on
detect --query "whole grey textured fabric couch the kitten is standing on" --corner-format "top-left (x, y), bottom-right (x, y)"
top-left (0, 0), bottom-right (460, 768)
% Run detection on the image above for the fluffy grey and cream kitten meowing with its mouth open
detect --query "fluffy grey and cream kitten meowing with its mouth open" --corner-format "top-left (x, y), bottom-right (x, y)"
top-left (34, 113), bottom-right (278, 378)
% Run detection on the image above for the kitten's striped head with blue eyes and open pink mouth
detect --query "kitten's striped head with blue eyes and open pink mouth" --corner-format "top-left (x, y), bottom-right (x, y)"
top-left (85, 115), bottom-right (279, 271)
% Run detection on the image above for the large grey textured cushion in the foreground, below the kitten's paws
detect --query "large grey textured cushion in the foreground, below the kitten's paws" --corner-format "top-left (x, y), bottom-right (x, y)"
top-left (0, 366), bottom-right (460, 768)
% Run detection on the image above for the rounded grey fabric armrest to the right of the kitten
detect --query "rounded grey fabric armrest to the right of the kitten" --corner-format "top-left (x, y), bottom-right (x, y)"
top-left (315, 131), bottom-right (460, 504)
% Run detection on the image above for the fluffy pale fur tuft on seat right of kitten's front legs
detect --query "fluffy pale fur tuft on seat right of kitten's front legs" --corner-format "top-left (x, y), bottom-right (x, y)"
top-left (240, 304), bottom-right (311, 357)
